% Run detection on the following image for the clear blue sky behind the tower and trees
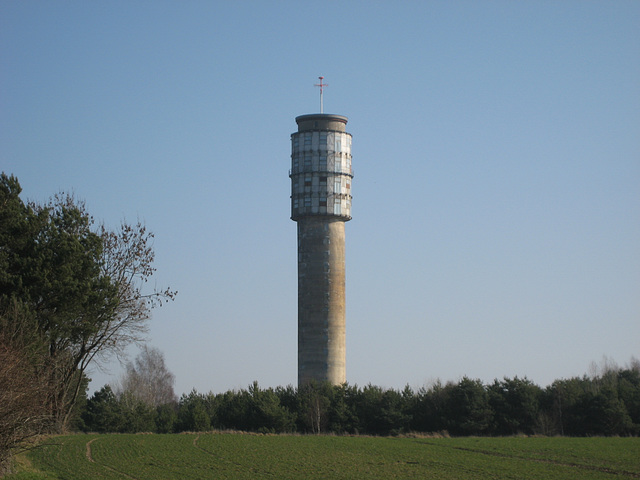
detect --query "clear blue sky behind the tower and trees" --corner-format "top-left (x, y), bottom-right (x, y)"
top-left (0, 0), bottom-right (640, 394)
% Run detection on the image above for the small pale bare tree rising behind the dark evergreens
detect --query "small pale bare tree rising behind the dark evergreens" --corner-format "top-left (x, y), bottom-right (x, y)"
top-left (116, 345), bottom-right (177, 407)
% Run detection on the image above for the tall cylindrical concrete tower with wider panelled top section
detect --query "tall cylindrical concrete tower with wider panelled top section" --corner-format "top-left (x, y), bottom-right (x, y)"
top-left (289, 113), bottom-right (353, 385)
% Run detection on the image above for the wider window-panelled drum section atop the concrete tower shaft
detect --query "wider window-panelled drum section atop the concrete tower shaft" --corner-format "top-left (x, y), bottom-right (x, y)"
top-left (289, 123), bottom-right (353, 221)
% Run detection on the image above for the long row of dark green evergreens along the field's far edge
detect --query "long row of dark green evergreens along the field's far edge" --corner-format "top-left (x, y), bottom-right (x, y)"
top-left (77, 360), bottom-right (640, 436)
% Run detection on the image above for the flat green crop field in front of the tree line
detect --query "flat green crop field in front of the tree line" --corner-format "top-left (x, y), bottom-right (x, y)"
top-left (6, 433), bottom-right (640, 480)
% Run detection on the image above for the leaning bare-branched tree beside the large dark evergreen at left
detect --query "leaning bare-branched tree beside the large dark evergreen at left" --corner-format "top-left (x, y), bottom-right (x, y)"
top-left (42, 212), bottom-right (177, 430)
